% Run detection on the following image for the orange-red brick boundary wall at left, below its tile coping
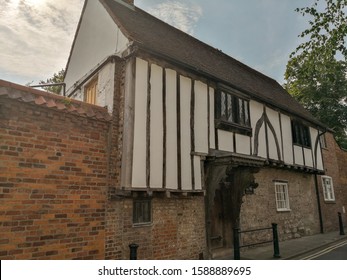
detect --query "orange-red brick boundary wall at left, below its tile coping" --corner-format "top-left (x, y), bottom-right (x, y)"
top-left (0, 97), bottom-right (108, 259)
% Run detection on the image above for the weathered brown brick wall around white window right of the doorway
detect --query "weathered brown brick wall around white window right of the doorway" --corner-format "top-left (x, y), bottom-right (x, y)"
top-left (241, 168), bottom-right (319, 243)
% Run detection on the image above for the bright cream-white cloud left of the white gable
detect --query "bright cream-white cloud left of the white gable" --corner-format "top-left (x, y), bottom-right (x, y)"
top-left (0, 0), bottom-right (83, 82)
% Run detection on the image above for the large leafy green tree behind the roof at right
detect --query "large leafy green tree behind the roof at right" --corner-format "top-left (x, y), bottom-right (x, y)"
top-left (284, 0), bottom-right (347, 148)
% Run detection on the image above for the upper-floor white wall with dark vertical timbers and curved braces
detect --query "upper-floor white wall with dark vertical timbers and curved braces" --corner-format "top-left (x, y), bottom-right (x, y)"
top-left (130, 58), bottom-right (322, 191)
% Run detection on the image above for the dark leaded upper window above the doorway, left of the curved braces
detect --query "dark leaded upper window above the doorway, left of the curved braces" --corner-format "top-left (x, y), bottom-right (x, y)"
top-left (216, 90), bottom-right (250, 134)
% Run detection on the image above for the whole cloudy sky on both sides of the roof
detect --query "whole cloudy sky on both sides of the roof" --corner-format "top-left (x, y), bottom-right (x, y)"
top-left (0, 0), bottom-right (313, 84)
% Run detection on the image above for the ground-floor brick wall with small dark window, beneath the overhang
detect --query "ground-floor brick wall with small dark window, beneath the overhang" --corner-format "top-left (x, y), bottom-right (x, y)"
top-left (106, 196), bottom-right (206, 260)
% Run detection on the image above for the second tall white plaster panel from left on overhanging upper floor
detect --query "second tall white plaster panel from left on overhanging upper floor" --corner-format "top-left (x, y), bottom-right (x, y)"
top-left (150, 64), bottom-right (164, 188)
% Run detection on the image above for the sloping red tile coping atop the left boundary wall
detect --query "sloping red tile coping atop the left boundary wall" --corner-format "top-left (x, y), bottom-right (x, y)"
top-left (0, 80), bottom-right (111, 121)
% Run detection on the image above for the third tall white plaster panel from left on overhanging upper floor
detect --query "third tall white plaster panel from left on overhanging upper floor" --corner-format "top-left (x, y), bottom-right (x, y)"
top-left (166, 69), bottom-right (178, 189)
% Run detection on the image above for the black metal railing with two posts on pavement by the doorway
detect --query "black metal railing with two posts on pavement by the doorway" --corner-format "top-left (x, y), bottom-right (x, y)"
top-left (233, 223), bottom-right (281, 260)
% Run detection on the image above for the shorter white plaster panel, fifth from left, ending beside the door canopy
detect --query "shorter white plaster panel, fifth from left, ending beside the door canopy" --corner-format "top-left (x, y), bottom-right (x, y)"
top-left (194, 81), bottom-right (208, 154)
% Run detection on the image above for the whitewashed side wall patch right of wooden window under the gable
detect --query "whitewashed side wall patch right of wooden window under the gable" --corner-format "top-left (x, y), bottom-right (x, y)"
top-left (96, 63), bottom-right (114, 113)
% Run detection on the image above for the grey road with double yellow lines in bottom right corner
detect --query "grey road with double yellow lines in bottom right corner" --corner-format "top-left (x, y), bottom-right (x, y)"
top-left (302, 240), bottom-right (347, 260)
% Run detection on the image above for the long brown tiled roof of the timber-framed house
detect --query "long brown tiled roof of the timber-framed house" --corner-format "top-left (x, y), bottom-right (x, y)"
top-left (100, 0), bottom-right (324, 129)
